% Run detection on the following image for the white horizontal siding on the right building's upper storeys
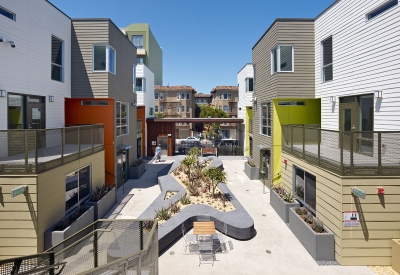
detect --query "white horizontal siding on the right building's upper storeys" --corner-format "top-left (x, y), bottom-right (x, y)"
top-left (315, 0), bottom-right (400, 131)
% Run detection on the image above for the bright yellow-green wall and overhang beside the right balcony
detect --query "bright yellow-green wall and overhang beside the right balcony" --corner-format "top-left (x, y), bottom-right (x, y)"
top-left (272, 98), bottom-right (321, 182)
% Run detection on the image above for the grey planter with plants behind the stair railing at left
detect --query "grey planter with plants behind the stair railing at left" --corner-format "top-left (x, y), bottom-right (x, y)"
top-left (44, 205), bottom-right (94, 252)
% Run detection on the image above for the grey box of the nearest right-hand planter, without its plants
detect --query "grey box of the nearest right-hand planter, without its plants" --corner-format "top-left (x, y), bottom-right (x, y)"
top-left (289, 208), bottom-right (335, 261)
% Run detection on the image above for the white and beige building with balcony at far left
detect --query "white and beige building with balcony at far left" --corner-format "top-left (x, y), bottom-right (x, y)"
top-left (0, 0), bottom-right (104, 259)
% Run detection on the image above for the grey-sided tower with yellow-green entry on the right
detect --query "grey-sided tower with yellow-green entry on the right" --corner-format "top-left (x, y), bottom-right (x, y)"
top-left (252, 19), bottom-right (320, 185)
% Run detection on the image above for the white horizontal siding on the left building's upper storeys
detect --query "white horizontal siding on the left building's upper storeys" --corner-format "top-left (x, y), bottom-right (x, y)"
top-left (0, 0), bottom-right (71, 129)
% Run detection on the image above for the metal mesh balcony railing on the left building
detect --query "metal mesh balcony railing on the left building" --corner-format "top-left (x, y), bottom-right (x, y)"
top-left (0, 124), bottom-right (104, 175)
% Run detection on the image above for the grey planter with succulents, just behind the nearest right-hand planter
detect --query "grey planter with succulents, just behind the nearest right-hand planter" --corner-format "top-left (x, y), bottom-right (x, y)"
top-left (269, 184), bottom-right (300, 223)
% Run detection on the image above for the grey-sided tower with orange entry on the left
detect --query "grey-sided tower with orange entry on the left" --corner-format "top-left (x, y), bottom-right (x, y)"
top-left (65, 18), bottom-right (137, 186)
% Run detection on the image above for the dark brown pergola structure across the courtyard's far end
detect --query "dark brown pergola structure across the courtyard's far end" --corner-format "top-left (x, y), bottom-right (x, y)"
top-left (146, 118), bottom-right (244, 156)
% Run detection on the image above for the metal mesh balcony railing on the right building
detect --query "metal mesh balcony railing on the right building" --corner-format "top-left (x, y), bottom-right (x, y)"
top-left (282, 125), bottom-right (400, 176)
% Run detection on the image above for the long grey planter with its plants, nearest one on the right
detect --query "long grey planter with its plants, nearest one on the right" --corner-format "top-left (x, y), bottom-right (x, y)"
top-left (289, 206), bottom-right (335, 261)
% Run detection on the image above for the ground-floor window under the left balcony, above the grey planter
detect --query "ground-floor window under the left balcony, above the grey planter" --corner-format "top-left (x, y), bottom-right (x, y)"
top-left (65, 166), bottom-right (92, 212)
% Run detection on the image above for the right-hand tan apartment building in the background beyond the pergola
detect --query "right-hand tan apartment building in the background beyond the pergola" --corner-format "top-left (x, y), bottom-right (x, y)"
top-left (211, 86), bottom-right (240, 140)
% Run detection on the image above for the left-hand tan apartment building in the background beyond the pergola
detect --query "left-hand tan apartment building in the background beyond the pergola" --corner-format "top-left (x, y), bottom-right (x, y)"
top-left (154, 85), bottom-right (196, 139)
